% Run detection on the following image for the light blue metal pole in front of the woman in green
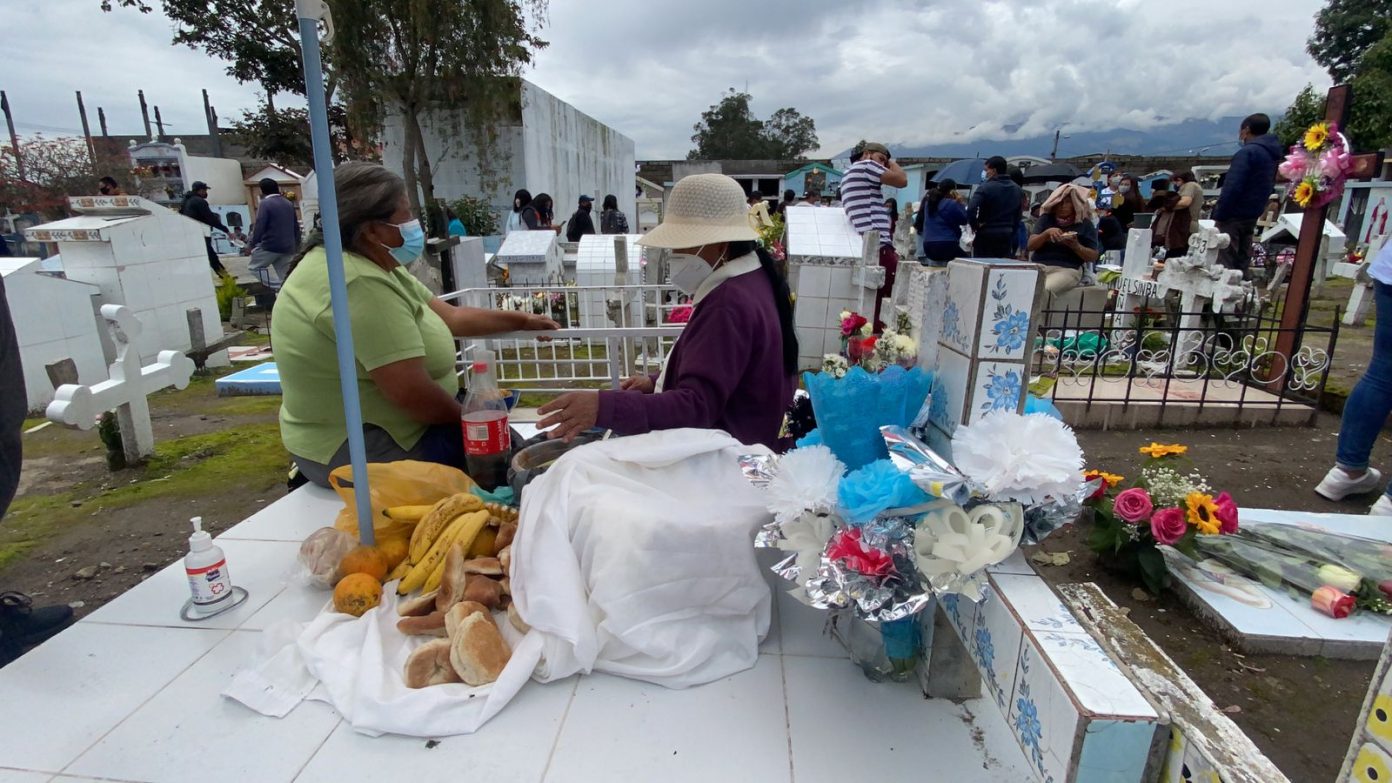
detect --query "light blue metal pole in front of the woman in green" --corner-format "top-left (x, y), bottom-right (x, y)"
top-left (295, 0), bottom-right (376, 545)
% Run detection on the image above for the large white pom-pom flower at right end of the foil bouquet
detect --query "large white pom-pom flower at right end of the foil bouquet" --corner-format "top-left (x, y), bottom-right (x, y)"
top-left (952, 411), bottom-right (1083, 506)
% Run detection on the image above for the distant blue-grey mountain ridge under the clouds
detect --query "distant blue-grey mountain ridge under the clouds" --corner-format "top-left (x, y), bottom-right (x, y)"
top-left (834, 117), bottom-right (1258, 157)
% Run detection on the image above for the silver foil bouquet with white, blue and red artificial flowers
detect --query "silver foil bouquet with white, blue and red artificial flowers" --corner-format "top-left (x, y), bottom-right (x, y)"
top-left (741, 415), bottom-right (1089, 680)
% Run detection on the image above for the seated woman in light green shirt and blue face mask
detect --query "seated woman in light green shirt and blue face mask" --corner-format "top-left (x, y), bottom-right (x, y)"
top-left (271, 162), bottom-right (558, 486)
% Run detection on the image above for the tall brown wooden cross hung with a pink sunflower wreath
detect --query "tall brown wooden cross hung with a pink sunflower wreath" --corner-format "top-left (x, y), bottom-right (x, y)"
top-left (1267, 85), bottom-right (1379, 393)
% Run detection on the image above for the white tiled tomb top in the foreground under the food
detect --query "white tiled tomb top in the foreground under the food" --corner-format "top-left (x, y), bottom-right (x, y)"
top-left (0, 488), bottom-right (1029, 783)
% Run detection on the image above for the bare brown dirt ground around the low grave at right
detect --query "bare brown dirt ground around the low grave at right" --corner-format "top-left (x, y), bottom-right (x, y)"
top-left (1037, 415), bottom-right (1392, 783)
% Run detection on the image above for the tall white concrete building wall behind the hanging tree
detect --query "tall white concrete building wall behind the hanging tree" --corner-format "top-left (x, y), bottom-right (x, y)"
top-left (381, 81), bottom-right (638, 228)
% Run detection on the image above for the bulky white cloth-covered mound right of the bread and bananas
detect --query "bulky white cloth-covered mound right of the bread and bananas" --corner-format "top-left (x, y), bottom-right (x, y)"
top-left (512, 429), bottom-right (771, 688)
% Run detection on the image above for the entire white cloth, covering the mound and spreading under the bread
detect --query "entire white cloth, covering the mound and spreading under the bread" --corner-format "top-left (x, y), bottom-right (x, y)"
top-left (223, 429), bottom-right (771, 737)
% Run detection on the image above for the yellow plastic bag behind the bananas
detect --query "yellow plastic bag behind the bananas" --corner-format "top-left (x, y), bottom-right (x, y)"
top-left (329, 460), bottom-right (476, 539)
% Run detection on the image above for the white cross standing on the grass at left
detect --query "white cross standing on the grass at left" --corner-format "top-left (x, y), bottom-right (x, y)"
top-left (46, 305), bottom-right (193, 464)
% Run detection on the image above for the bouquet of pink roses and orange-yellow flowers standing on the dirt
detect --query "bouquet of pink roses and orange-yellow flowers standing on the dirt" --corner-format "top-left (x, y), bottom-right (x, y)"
top-left (1084, 443), bottom-right (1237, 595)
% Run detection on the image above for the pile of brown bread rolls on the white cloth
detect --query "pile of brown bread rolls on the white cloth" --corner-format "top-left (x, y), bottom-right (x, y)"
top-left (397, 545), bottom-right (528, 688)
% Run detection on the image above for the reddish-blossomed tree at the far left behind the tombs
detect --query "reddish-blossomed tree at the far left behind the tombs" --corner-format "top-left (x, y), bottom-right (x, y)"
top-left (0, 135), bottom-right (134, 219)
